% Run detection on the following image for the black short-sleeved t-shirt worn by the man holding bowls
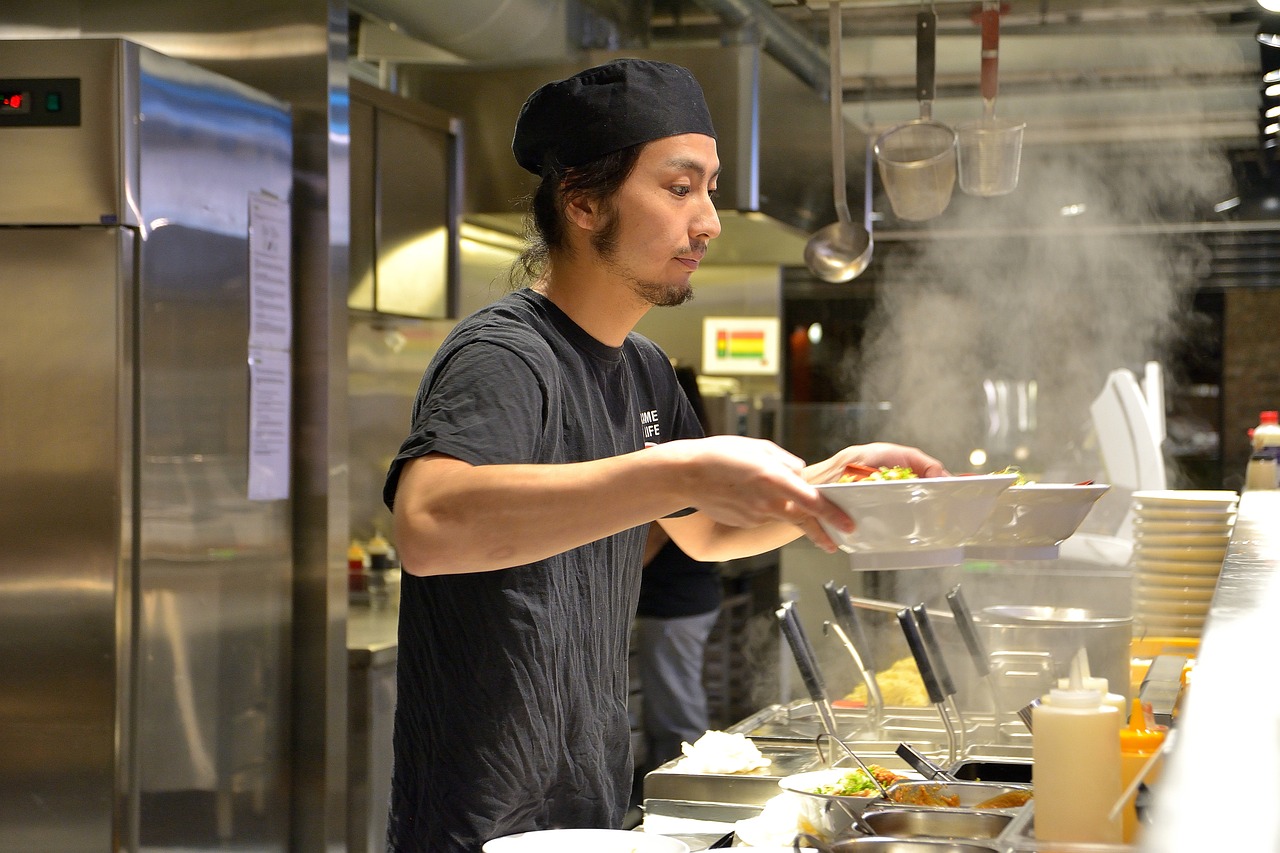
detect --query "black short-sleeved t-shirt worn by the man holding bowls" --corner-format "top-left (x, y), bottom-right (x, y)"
top-left (384, 291), bottom-right (701, 853)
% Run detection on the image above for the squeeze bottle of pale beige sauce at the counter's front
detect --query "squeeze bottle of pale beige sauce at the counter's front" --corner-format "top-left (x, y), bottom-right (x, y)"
top-left (1032, 667), bottom-right (1124, 849)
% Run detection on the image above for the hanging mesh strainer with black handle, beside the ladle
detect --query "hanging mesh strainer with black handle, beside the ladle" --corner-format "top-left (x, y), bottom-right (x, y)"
top-left (876, 9), bottom-right (956, 222)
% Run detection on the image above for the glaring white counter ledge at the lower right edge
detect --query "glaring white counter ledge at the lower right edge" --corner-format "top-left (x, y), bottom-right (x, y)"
top-left (1142, 492), bottom-right (1280, 853)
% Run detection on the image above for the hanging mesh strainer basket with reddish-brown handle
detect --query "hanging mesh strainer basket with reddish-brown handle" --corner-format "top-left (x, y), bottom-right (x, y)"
top-left (956, 0), bottom-right (1027, 197)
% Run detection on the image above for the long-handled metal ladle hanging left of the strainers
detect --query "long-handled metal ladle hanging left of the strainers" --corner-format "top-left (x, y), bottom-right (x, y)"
top-left (804, 3), bottom-right (873, 283)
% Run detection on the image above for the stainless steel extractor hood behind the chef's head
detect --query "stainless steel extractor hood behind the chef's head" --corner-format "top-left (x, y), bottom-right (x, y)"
top-left (399, 45), bottom-right (865, 264)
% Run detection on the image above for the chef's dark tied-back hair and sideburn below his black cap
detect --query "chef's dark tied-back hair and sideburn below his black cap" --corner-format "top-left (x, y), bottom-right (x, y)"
top-left (511, 145), bottom-right (644, 286)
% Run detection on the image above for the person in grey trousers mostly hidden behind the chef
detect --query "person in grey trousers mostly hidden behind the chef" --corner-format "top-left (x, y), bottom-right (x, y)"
top-left (635, 365), bottom-right (723, 770)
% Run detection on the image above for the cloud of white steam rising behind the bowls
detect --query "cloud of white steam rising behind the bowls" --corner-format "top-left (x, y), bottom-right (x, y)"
top-left (845, 21), bottom-right (1242, 475)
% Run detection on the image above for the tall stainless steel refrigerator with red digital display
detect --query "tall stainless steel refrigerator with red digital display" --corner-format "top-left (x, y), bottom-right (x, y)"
top-left (0, 38), bottom-right (292, 853)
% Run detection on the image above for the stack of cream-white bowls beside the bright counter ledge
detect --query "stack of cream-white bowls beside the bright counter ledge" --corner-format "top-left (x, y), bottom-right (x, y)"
top-left (1133, 489), bottom-right (1239, 637)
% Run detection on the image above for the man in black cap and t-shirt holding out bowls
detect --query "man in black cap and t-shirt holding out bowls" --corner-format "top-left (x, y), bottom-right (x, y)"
top-left (384, 59), bottom-right (942, 853)
